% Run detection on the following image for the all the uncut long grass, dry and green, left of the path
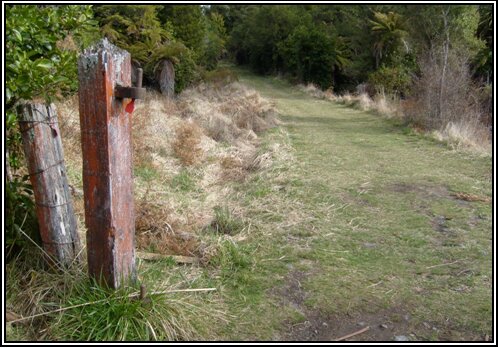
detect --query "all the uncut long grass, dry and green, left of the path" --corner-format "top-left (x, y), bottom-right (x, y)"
top-left (7, 72), bottom-right (279, 341)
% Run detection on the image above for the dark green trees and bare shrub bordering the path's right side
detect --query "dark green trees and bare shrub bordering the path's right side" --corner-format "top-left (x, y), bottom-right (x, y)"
top-left (218, 4), bottom-right (492, 150)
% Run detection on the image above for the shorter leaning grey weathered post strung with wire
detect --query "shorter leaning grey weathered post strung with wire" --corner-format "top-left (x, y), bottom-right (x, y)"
top-left (18, 103), bottom-right (81, 266)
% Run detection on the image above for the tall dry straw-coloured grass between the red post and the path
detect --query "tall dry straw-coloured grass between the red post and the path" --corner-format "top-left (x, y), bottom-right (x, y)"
top-left (56, 78), bottom-right (285, 260)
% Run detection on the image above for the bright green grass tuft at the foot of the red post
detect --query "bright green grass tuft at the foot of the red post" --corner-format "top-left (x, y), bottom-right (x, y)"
top-left (52, 282), bottom-right (199, 341)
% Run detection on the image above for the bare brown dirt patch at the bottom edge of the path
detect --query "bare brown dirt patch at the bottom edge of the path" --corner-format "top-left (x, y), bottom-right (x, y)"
top-left (273, 269), bottom-right (489, 342)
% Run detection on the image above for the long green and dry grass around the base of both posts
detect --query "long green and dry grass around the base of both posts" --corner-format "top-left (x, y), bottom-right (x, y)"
top-left (7, 250), bottom-right (225, 341)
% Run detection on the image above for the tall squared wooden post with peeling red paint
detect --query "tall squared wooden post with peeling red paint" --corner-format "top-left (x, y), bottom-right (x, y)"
top-left (78, 39), bottom-right (136, 288)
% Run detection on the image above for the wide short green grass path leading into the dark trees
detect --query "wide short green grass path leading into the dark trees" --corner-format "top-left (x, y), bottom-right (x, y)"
top-left (216, 73), bottom-right (492, 340)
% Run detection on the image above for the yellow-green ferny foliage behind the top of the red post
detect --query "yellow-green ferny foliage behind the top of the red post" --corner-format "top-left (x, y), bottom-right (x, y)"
top-left (95, 5), bottom-right (230, 93)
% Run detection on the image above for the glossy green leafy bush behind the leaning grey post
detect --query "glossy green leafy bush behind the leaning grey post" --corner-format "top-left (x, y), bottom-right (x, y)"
top-left (5, 5), bottom-right (97, 256)
